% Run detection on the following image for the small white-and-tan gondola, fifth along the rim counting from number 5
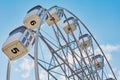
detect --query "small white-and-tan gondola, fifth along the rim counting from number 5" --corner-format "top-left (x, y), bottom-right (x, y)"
top-left (79, 34), bottom-right (92, 49)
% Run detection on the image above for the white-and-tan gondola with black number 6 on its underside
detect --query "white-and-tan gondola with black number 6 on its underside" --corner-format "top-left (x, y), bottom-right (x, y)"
top-left (23, 5), bottom-right (46, 30)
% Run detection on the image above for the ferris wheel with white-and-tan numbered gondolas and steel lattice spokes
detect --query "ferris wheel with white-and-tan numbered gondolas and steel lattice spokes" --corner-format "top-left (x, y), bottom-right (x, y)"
top-left (2, 5), bottom-right (117, 80)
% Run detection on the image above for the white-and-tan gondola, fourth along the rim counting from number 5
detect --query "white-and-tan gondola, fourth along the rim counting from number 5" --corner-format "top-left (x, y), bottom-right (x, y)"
top-left (63, 17), bottom-right (78, 34)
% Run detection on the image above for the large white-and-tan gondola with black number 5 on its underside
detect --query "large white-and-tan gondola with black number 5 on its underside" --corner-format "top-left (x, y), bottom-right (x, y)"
top-left (2, 26), bottom-right (35, 60)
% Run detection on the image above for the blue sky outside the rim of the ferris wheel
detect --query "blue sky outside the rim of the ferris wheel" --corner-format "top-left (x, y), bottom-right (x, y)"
top-left (0, 0), bottom-right (120, 80)
